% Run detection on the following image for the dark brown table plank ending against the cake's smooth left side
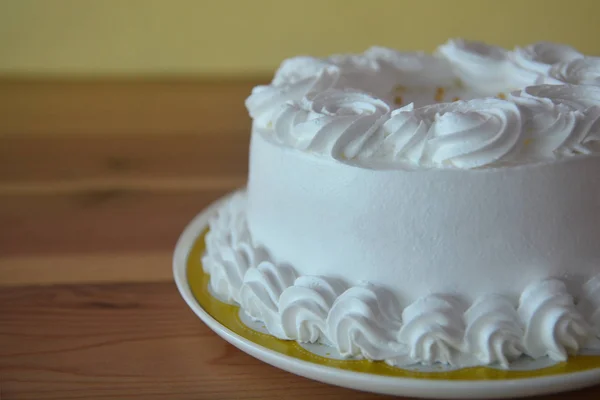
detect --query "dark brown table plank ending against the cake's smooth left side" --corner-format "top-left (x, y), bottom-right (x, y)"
top-left (0, 133), bottom-right (249, 186)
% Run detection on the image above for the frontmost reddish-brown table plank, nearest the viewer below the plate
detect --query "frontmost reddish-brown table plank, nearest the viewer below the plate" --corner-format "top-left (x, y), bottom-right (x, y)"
top-left (0, 283), bottom-right (390, 400)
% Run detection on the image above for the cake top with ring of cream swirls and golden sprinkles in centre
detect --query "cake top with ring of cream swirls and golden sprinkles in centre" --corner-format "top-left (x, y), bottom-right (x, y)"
top-left (246, 39), bottom-right (600, 169)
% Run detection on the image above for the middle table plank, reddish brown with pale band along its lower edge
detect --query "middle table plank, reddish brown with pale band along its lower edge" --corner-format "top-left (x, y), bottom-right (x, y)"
top-left (0, 187), bottom-right (234, 285)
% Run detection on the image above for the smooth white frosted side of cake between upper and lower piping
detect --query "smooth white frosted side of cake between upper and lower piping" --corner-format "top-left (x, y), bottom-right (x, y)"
top-left (247, 132), bottom-right (600, 301)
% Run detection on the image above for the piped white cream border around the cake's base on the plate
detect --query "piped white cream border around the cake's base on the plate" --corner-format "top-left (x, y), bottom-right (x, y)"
top-left (203, 192), bottom-right (600, 368)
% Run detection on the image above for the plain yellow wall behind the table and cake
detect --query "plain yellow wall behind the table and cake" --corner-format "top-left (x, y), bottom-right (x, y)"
top-left (0, 0), bottom-right (600, 76)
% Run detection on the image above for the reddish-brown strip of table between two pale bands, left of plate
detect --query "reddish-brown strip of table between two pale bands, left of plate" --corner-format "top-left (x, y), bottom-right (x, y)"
top-left (0, 188), bottom-right (227, 258)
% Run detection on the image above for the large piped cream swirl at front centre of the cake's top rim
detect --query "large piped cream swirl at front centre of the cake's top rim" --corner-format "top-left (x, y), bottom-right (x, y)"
top-left (361, 99), bottom-right (522, 169)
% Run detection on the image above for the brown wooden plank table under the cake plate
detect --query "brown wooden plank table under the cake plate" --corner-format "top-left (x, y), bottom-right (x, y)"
top-left (0, 82), bottom-right (600, 400)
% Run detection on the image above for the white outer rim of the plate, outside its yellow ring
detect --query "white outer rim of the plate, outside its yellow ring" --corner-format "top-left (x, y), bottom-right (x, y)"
top-left (173, 193), bottom-right (600, 399)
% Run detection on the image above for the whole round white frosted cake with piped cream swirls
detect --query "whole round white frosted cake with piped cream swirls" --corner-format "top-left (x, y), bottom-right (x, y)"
top-left (202, 40), bottom-right (600, 368)
